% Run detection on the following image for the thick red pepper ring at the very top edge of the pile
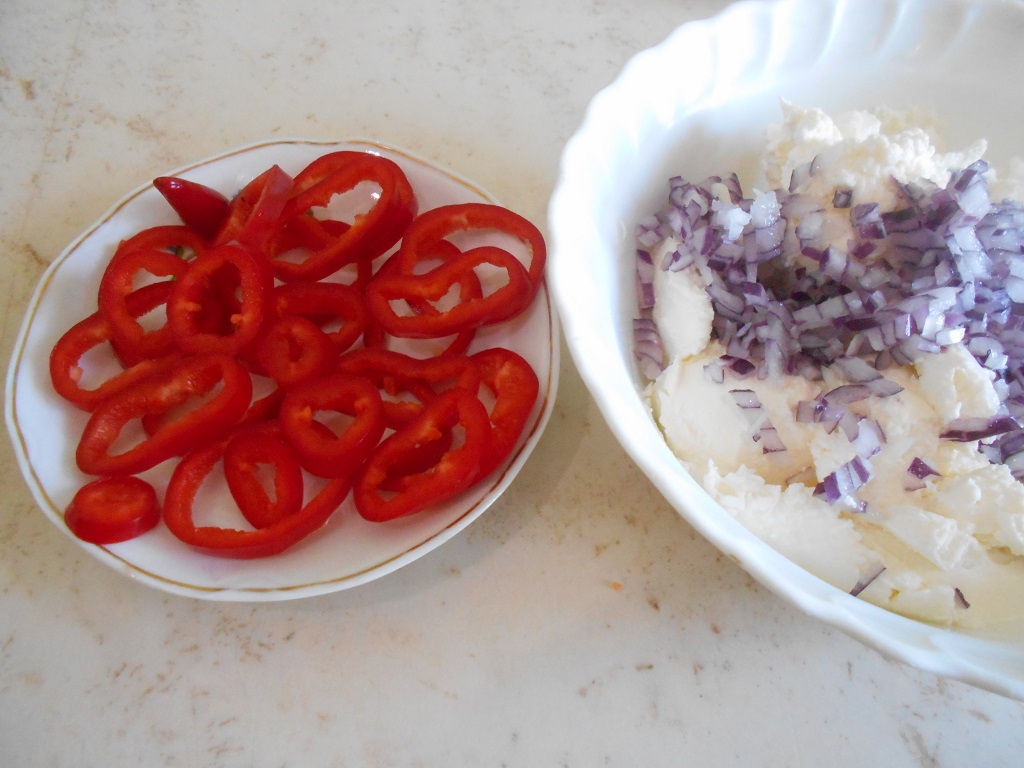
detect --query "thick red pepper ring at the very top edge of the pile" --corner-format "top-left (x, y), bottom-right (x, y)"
top-left (273, 152), bottom-right (416, 282)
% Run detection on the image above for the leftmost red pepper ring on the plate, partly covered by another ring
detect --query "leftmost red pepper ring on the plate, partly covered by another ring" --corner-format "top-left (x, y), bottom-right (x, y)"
top-left (49, 284), bottom-right (184, 411)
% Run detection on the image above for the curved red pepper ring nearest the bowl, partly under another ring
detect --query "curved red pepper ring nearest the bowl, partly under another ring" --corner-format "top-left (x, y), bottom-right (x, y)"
top-left (394, 203), bottom-right (548, 295)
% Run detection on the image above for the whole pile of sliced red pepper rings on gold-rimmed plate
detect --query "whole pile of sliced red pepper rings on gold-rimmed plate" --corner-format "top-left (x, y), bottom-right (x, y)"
top-left (50, 152), bottom-right (546, 558)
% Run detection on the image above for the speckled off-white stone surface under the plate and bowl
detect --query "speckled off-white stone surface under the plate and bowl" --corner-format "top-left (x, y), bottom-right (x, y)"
top-left (0, 0), bottom-right (1024, 768)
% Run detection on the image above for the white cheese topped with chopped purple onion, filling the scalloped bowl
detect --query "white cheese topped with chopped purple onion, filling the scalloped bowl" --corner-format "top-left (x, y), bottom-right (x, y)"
top-left (634, 101), bottom-right (1024, 627)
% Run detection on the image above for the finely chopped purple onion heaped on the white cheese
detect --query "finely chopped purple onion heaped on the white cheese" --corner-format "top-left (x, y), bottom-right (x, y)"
top-left (635, 158), bottom-right (1024, 499)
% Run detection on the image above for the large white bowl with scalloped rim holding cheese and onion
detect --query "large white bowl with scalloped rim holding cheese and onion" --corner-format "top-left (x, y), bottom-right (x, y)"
top-left (549, 0), bottom-right (1024, 698)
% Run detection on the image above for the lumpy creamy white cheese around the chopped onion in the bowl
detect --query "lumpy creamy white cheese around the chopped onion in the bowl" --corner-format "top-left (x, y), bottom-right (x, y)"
top-left (647, 103), bottom-right (1024, 626)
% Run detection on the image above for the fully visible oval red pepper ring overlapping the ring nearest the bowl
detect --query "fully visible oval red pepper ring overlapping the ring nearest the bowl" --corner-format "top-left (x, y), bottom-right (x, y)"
top-left (367, 246), bottom-right (534, 339)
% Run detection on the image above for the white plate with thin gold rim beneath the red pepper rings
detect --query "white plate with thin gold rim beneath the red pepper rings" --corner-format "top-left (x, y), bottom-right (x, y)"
top-left (6, 139), bottom-right (559, 601)
